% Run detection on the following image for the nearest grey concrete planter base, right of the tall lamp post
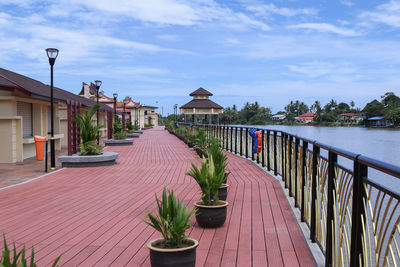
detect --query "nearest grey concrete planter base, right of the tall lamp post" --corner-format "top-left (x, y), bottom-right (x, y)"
top-left (58, 151), bottom-right (118, 168)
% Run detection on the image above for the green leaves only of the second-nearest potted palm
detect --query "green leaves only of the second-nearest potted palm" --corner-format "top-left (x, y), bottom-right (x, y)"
top-left (186, 155), bottom-right (225, 206)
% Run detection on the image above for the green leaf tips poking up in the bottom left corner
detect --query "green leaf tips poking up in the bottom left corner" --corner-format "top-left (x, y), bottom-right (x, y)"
top-left (0, 234), bottom-right (61, 267)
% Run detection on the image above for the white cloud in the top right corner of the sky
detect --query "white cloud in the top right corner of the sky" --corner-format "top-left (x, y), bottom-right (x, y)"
top-left (360, 0), bottom-right (400, 28)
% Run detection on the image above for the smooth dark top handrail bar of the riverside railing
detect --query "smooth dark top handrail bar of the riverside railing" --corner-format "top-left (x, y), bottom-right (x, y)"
top-left (178, 122), bottom-right (400, 178)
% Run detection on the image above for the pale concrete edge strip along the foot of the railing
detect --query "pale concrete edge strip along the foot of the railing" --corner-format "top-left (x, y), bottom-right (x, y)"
top-left (224, 150), bottom-right (325, 267)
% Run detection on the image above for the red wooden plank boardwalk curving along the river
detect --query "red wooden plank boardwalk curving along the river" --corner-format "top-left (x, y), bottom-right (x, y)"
top-left (0, 128), bottom-right (315, 267)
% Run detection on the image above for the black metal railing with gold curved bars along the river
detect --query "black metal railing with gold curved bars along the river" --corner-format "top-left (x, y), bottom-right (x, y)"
top-left (179, 123), bottom-right (400, 266)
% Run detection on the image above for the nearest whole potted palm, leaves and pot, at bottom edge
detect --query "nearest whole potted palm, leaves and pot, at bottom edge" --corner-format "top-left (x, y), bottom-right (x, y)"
top-left (145, 187), bottom-right (199, 267)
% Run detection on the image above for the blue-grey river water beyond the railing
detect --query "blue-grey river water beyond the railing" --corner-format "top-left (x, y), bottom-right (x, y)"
top-left (238, 125), bottom-right (400, 193)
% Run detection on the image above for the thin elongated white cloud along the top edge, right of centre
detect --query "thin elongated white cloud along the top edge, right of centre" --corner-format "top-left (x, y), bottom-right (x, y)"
top-left (247, 4), bottom-right (318, 17)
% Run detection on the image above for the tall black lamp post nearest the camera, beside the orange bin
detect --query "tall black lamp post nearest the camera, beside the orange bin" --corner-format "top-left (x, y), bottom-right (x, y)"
top-left (46, 48), bottom-right (58, 170)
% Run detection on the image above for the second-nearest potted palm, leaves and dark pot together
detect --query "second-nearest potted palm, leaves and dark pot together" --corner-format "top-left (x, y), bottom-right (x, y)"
top-left (187, 155), bottom-right (229, 228)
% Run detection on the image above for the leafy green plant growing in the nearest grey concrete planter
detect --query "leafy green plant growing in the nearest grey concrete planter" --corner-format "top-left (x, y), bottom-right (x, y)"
top-left (73, 104), bottom-right (103, 155)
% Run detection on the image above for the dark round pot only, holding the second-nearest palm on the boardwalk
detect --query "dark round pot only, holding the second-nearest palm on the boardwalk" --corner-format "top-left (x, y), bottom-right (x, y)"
top-left (194, 200), bottom-right (229, 228)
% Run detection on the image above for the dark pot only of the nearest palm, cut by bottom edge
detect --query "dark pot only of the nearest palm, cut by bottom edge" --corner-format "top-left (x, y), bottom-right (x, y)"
top-left (147, 238), bottom-right (199, 267)
